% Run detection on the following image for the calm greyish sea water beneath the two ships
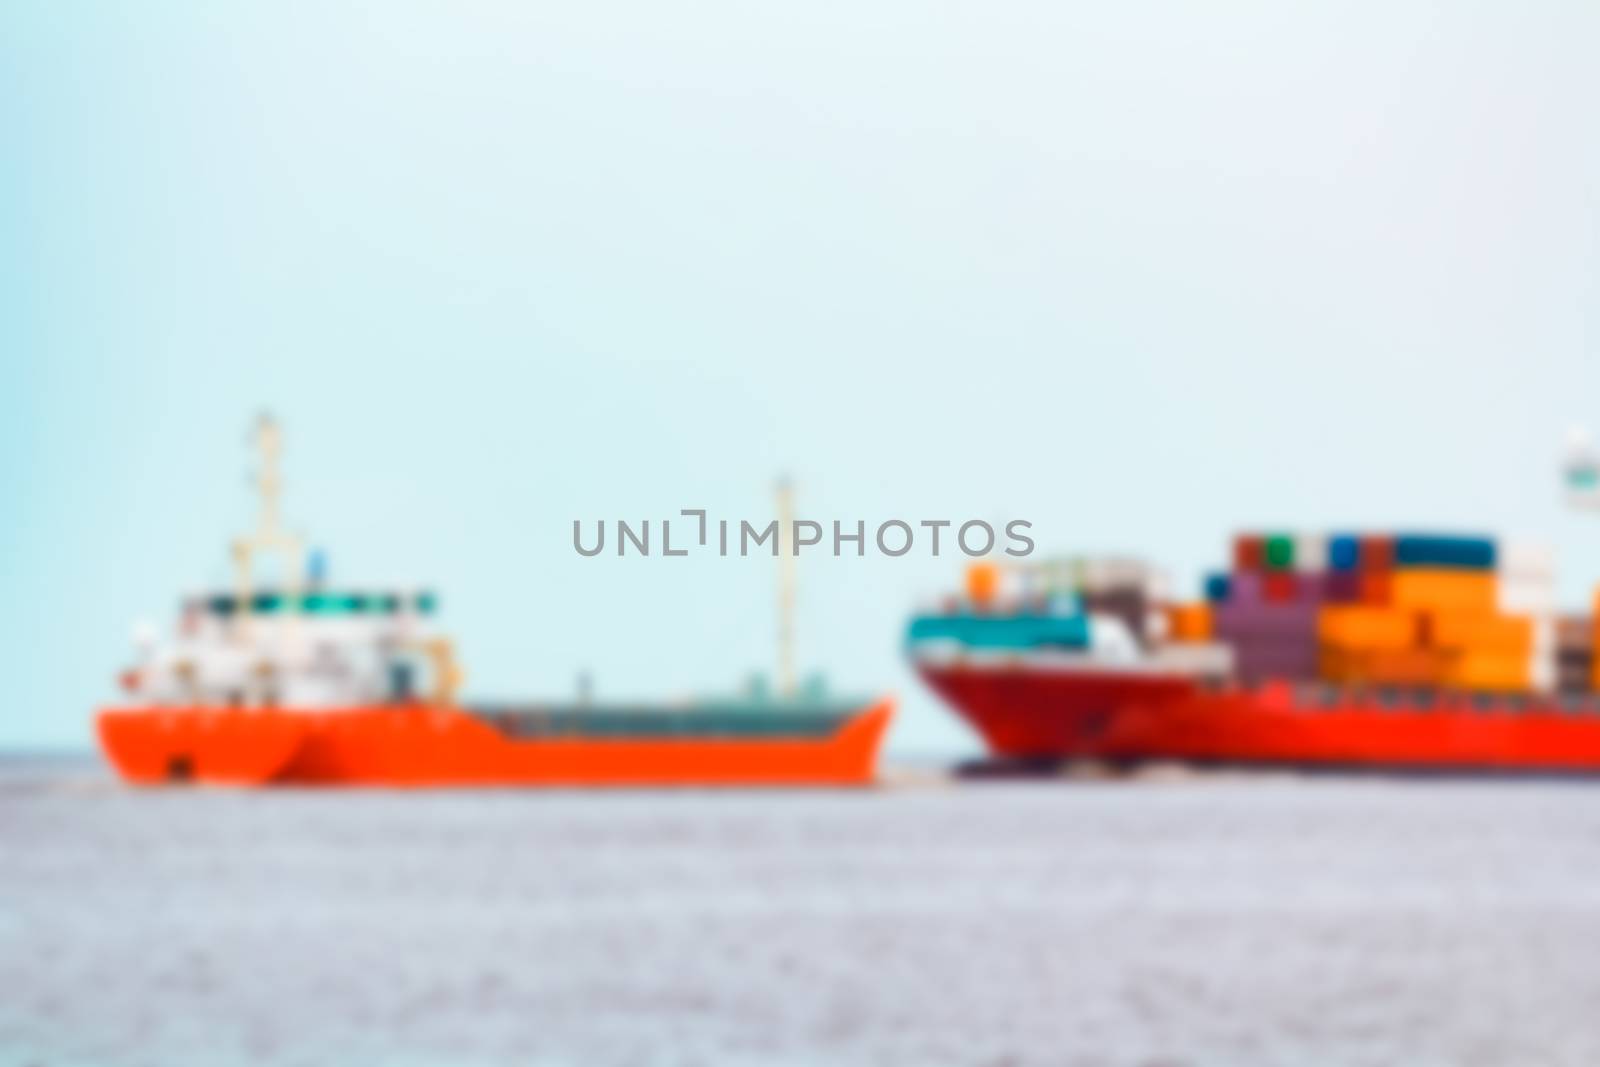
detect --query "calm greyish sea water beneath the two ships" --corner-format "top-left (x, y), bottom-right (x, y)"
top-left (0, 761), bottom-right (1600, 1067)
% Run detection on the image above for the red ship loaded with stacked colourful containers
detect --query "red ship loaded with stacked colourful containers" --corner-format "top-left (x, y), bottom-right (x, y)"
top-left (909, 534), bottom-right (1600, 773)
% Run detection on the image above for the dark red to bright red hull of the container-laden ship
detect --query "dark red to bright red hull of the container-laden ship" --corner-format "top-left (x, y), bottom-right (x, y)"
top-left (920, 665), bottom-right (1600, 774)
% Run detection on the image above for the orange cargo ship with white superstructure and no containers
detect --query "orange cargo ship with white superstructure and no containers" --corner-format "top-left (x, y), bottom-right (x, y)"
top-left (96, 421), bottom-right (893, 787)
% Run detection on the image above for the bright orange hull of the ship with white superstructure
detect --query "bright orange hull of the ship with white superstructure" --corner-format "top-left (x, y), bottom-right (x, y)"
top-left (98, 701), bottom-right (893, 787)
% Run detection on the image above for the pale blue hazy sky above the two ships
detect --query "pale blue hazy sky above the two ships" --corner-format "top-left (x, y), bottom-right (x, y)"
top-left (0, 2), bottom-right (1600, 752)
